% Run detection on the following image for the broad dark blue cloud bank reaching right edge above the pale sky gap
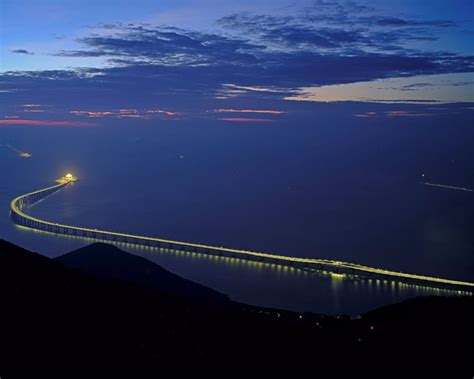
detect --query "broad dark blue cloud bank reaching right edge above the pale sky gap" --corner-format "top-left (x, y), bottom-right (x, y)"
top-left (45, 14), bottom-right (474, 91)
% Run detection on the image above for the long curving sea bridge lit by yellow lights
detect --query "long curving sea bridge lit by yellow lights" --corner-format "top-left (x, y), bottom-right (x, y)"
top-left (10, 181), bottom-right (474, 292)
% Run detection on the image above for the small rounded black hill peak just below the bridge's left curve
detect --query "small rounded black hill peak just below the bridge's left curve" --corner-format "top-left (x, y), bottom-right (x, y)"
top-left (55, 243), bottom-right (229, 302)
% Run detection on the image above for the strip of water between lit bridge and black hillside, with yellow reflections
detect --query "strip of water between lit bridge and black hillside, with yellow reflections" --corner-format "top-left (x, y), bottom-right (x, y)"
top-left (15, 225), bottom-right (469, 314)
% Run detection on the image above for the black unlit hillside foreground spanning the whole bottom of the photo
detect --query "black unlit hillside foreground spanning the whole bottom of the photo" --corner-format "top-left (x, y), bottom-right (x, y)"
top-left (0, 240), bottom-right (473, 379)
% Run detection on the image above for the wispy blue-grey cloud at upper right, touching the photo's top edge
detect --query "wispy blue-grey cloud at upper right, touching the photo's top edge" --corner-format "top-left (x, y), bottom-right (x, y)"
top-left (218, 2), bottom-right (457, 54)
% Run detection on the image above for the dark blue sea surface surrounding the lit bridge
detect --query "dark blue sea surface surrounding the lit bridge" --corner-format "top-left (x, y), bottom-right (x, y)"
top-left (0, 113), bottom-right (474, 313)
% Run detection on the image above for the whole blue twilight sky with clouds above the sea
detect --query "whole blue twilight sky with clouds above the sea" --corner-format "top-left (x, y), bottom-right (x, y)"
top-left (0, 0), bottom-right (474, 127)
